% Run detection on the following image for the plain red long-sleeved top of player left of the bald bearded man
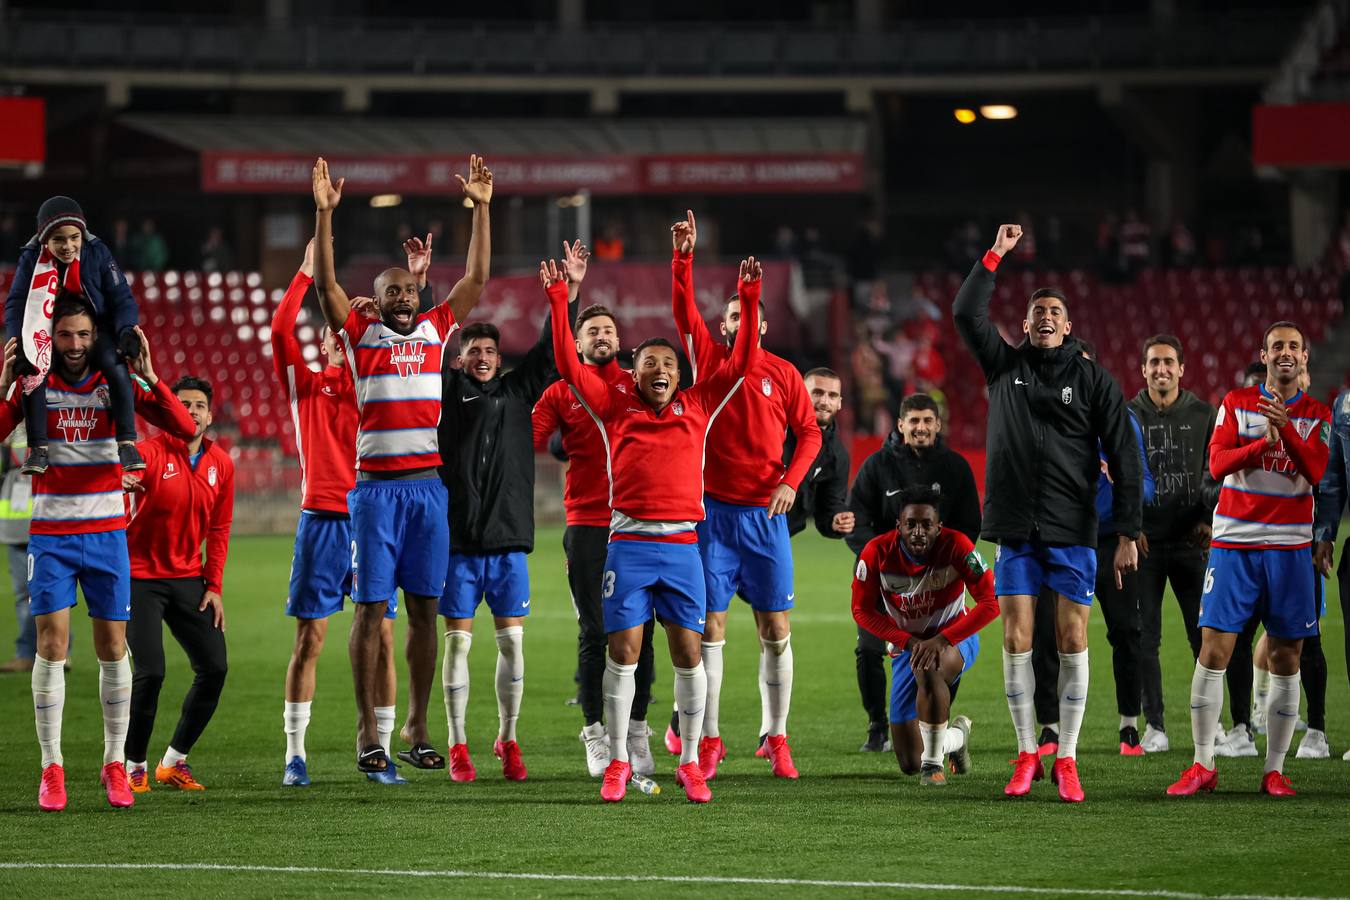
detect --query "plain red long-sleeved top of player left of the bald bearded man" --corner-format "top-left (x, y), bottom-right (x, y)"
top-left (271, 273), bottom-right (358, 513)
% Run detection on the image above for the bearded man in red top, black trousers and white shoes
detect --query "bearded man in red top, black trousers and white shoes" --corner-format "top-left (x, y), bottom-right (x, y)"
top-left (533, 254), bottom-right (656, 779)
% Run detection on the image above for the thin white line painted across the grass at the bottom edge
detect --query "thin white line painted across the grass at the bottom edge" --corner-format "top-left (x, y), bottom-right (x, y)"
top-left (0, 862), bottom-right (1346, 900)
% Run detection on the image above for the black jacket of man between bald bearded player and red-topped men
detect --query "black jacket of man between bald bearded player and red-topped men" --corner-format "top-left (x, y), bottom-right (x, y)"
top-left (439, 318), bottom-right (558, 553)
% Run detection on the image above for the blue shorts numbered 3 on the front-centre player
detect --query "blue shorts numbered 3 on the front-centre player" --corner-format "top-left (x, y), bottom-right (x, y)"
top-left (599, 541), bottom-right (707, 634)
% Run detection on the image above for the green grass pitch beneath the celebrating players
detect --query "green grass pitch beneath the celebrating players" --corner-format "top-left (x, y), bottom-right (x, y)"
top-left (0, 529), bottom-right (1350, 899)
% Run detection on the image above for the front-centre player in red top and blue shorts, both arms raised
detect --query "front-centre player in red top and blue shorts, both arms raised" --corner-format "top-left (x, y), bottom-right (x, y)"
top-left (539, 251), bottom-right (761, 803)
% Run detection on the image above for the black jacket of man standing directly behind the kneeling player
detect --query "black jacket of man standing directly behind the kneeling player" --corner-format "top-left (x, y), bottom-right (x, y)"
top-left (844, 432), bottom-right (980, 553)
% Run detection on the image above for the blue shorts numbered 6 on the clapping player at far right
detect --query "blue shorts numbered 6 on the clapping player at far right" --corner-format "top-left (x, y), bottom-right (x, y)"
top-left (1200, 546), bottom-right (1318, 641)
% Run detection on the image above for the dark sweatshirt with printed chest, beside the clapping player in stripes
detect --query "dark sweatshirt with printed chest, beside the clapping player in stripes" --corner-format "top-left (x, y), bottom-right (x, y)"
top-left (1130, 390), bottom-right (1219, 541)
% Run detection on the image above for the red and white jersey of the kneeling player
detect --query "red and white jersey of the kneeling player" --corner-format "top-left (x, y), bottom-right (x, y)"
top-left (853, 528), bottom-right (999, 650)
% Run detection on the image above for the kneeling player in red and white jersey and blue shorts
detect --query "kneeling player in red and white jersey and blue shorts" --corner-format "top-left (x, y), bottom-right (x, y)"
top-left (853, 486), bottom-right (999, 785)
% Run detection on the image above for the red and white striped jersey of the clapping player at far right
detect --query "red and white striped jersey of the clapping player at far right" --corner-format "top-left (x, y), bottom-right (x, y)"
top-left (1210, 385), bottom-right (1331, 549)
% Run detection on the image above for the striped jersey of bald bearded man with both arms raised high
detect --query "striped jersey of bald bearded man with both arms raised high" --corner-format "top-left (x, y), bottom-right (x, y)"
top-left (340, 304), bottom-right (459, 472)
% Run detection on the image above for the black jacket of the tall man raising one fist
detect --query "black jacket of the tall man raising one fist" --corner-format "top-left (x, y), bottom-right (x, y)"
top-left (952, 262), bottom-right (1142, 546)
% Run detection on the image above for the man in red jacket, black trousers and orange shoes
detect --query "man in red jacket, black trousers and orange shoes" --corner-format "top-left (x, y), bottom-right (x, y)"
top-left (123, 375), bottom-right (235, 793)
